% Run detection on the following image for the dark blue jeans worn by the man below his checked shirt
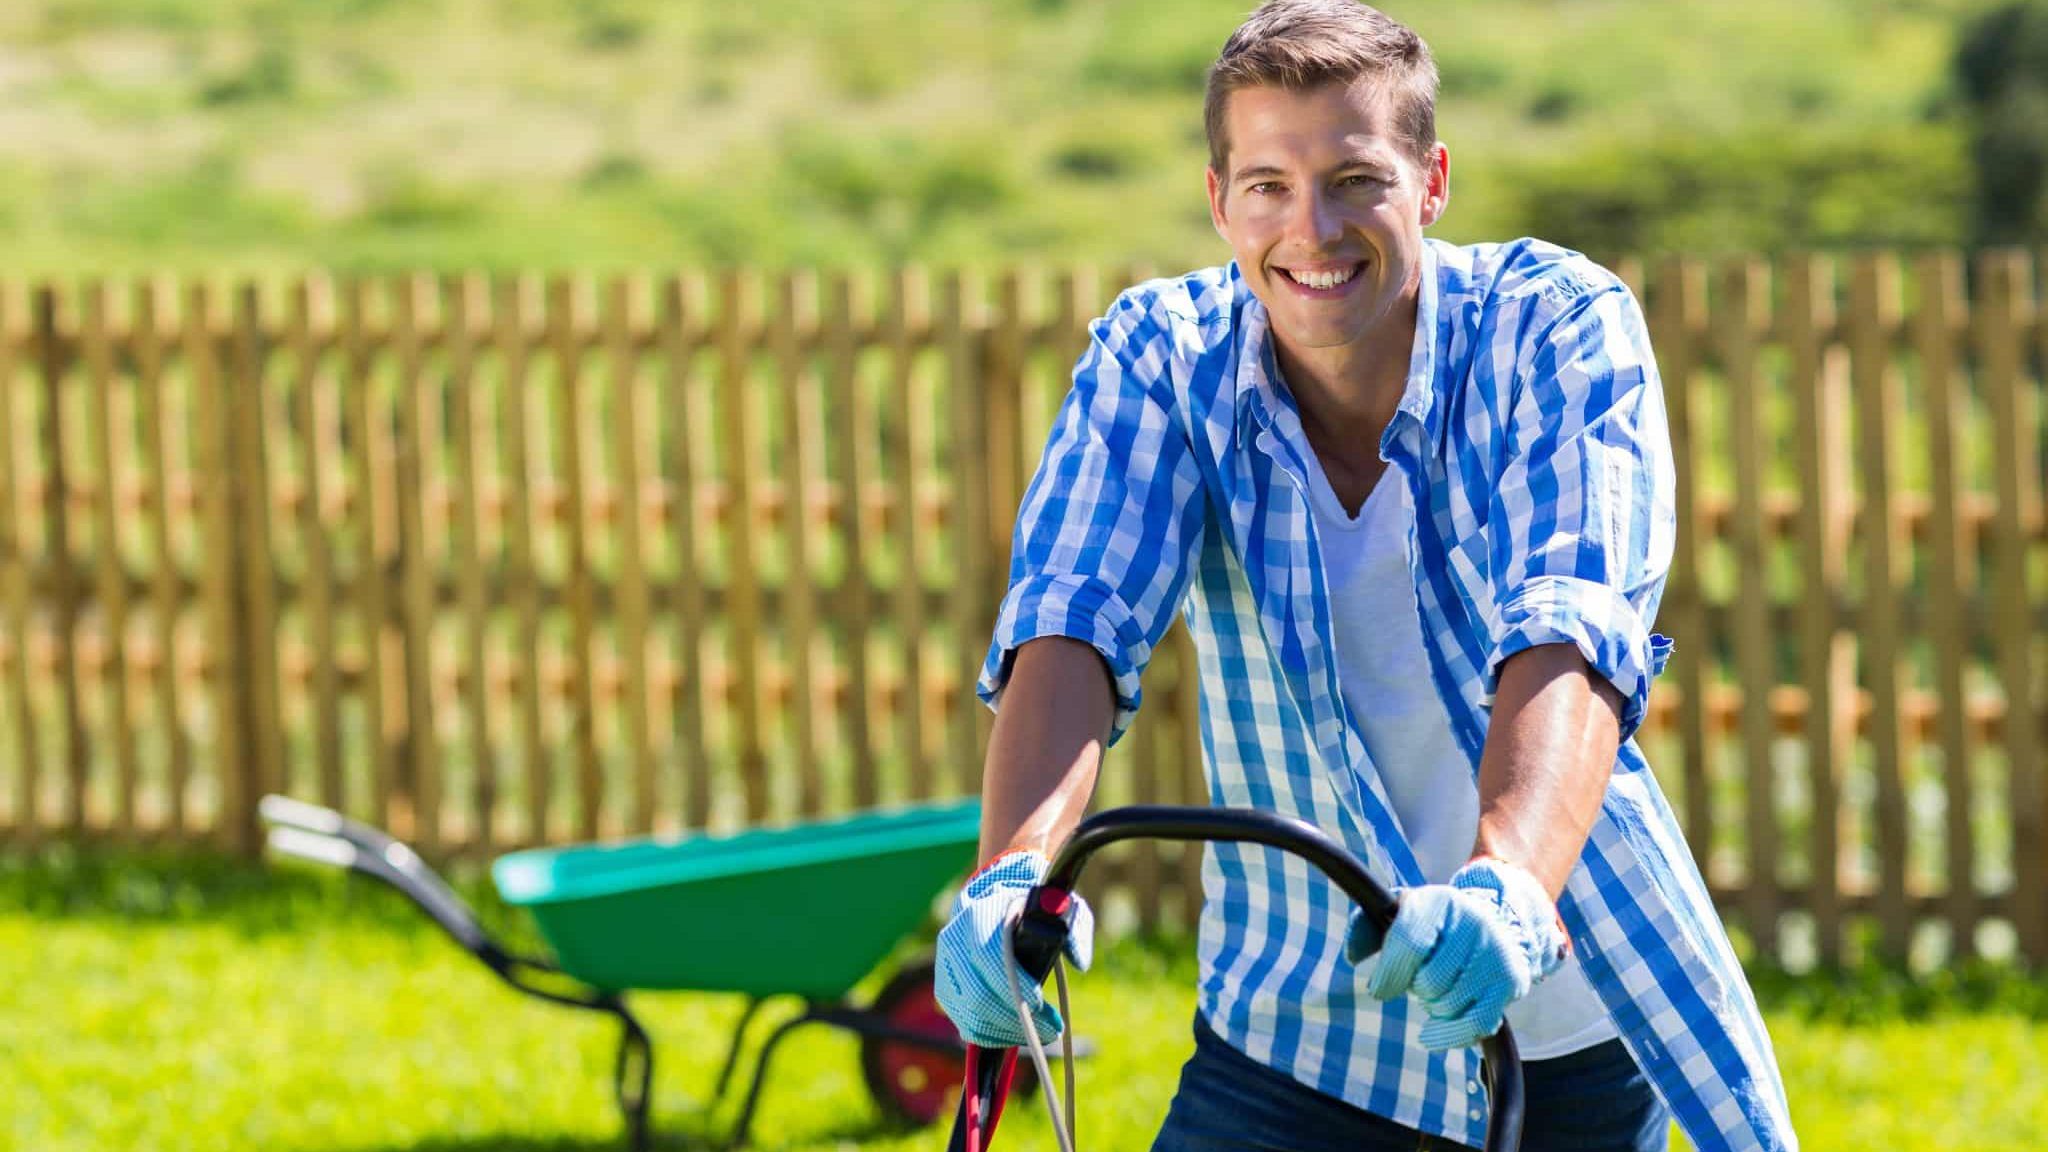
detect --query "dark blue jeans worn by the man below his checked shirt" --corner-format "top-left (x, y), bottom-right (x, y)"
top-left (1153, 1015), bottom-right (1671, 1152)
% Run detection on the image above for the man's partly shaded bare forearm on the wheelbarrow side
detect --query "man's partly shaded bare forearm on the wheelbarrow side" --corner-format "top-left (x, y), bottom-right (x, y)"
top-left (981, 635), bottom-right (1116, 861)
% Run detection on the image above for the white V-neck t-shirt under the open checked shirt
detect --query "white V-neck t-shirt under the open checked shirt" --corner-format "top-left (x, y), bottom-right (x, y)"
top-left (1305, 451), bottom-right (1618, 1060)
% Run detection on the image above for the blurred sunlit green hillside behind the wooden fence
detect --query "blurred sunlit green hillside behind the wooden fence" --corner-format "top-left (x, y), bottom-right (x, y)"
top-left (0, 0), bottom-right (1987, 275)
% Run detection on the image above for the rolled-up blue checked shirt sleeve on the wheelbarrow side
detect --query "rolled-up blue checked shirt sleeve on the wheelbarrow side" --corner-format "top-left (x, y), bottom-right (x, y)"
top-left (977, 289), bottom-right (1206, 744)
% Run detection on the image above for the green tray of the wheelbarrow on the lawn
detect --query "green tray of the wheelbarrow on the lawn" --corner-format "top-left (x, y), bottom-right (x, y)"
top-left (492, 799), bottom-right (981, 1000)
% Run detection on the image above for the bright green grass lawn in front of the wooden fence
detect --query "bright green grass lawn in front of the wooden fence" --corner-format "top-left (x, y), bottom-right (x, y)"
top-left (12, 844), bottom-right (2048, 1152)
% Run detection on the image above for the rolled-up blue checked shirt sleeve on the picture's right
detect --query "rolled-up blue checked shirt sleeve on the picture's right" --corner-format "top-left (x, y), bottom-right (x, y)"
top-left (1485, 281), bottom-right (1677, 740)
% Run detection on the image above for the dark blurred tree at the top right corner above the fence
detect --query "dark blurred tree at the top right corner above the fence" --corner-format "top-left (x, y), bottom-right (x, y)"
top-left (1956, 0), bottom-right (2048, 244)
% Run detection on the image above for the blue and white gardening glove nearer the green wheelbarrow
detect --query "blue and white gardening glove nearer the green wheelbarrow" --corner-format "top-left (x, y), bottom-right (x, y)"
top-left (936, 851), bottom-right (1096, 1047)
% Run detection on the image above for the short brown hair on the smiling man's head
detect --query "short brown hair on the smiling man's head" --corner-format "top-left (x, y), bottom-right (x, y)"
top-left (1202, 0), bottom-right (1436, 176)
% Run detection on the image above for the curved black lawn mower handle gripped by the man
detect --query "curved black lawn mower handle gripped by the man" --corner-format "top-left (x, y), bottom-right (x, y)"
top-left (948, 806), bottom-right (1524, 1152)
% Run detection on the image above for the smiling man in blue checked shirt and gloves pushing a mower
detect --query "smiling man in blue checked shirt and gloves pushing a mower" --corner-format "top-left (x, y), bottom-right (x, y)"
top-left (938, 0), bottom-right (1796, 1152)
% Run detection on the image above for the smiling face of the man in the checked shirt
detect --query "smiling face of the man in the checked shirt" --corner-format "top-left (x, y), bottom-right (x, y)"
top-left (1208, 82), bottom-right (1450, 351)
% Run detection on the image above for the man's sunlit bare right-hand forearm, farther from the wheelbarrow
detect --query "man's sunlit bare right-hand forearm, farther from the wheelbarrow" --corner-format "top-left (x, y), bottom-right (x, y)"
top-left (1473, 644), bottom-right (1622, 898)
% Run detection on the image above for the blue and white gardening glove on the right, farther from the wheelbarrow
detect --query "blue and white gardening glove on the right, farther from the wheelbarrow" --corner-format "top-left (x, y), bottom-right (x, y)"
top-left (1343, 857), bottom-right (1571, 1052)
